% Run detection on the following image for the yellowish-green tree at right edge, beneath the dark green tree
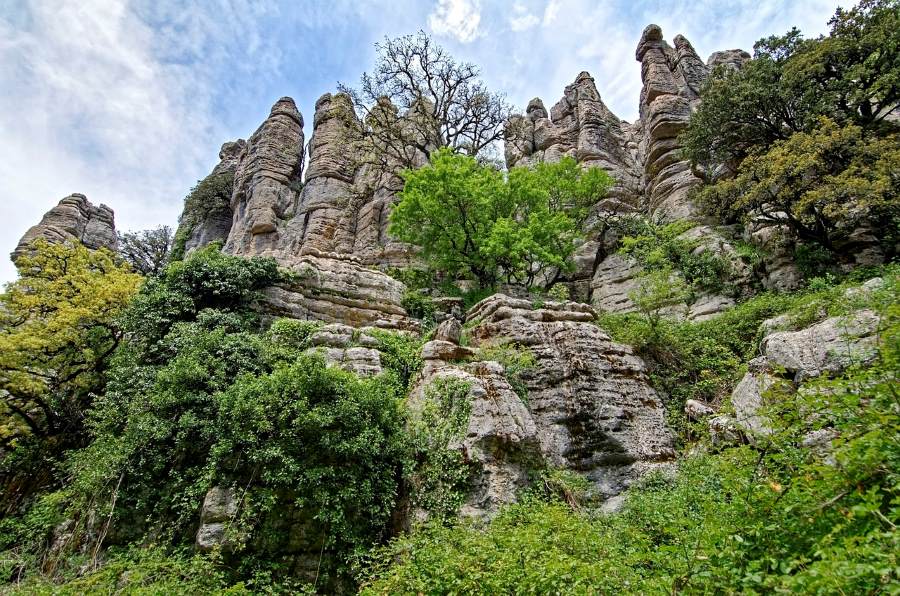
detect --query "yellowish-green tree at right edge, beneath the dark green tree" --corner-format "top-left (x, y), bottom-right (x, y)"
top-left (699, 117), bottom-right (900, 251)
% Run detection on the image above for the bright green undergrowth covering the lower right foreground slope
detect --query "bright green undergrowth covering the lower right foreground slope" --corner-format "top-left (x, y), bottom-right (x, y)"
top-left (363, 271), bottom-right (900, 594)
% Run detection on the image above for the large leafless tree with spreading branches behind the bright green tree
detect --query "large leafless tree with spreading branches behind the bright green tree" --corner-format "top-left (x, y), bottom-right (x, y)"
top-left (338, 31), bottom-right (511, 171)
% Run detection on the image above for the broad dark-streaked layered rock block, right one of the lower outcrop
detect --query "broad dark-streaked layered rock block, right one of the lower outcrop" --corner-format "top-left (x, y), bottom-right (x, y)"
top-left (467, 295), bottom-right (674, 496)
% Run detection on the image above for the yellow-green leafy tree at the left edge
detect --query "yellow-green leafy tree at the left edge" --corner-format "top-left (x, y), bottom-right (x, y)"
top-left (0, 240), bottom-right (142, 445)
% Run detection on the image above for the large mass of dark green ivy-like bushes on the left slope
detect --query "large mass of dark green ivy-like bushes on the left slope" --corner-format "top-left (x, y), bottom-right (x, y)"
top-left (0, 246), bottom-right (406, 585)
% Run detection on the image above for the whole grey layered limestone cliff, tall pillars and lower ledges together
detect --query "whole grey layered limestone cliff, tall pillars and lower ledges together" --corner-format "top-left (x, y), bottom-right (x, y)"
top-left (15, 25), bottom-right (784, 520)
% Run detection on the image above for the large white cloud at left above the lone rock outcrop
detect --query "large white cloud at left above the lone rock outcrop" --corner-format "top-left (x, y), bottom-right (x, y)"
top-left (0, 0), bottom-right (229, 280)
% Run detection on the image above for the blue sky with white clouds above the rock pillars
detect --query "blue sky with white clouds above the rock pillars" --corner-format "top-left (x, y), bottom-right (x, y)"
top-left (0, 0), bottom-right (847, 282)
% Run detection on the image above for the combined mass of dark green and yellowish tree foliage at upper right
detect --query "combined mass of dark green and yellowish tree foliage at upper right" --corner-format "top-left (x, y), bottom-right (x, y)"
top-left (681, 0), bottom-right (900, 258)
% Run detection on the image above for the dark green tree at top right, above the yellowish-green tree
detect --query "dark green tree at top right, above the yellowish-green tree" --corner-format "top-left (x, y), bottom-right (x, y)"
top-left (681, 0), bottom-right (900, 175)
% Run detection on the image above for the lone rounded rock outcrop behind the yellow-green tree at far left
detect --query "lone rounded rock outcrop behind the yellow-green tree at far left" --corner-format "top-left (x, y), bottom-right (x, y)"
top-left (10, 193), bottom-right (118, 262)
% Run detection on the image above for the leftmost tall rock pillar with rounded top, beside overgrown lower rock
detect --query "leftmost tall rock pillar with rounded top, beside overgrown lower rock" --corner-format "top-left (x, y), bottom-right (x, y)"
top-left (225, 97), bottom-right (303, 256)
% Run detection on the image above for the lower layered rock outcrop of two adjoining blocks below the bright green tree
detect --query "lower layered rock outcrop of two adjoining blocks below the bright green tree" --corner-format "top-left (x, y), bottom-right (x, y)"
top-left (414, 294), bottom-right (674, 515)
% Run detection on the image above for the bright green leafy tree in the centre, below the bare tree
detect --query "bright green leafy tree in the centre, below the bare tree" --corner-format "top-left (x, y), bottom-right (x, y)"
top-left (390, 150), bottom-right (611, 288)
